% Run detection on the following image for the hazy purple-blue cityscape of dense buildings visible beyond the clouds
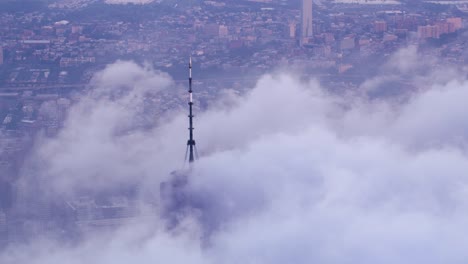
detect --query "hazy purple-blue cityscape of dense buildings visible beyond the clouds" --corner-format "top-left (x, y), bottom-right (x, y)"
top-left (0, 0), bottom-right (468, 252)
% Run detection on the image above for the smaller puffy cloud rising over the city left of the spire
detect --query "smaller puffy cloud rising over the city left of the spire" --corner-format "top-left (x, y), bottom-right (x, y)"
top-left (25, 62), bottom-right (185, 194)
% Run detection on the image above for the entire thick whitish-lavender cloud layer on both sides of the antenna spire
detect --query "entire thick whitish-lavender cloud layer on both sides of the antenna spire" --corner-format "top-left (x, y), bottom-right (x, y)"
top-left (0, 49), bottom-right (468, 264)
